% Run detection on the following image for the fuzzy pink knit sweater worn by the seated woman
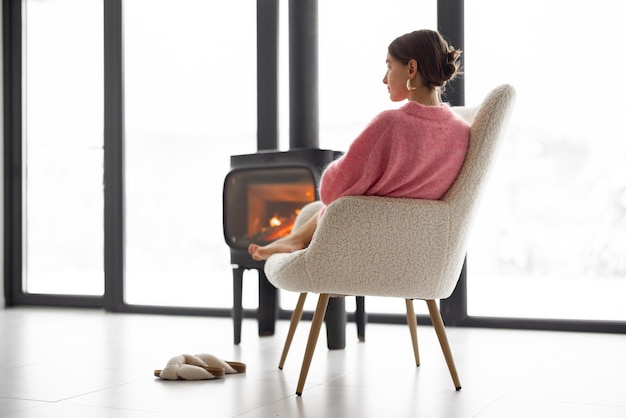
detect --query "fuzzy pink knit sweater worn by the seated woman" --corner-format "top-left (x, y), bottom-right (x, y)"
top-left (319, 101), bottom-right (470, 206)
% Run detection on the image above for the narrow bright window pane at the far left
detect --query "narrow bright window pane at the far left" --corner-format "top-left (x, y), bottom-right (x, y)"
top-left (22, 0), bottom-right (104, 295)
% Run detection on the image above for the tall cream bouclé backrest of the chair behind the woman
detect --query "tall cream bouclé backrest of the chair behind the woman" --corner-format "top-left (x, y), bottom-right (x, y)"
top-left (442, 84), bottom-right (515, 284)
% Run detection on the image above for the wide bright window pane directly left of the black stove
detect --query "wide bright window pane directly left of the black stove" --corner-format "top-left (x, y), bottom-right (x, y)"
top-left (123, 0), bottom-right (257, 308)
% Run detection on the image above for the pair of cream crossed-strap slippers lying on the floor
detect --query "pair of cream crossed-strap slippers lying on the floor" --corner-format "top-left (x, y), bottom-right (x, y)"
top-left (154, 354), bottom-right (246, 380)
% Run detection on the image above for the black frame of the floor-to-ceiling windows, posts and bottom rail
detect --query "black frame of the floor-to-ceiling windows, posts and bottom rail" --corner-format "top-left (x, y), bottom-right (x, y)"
top-left (2, 0), bottom-right (626, 333)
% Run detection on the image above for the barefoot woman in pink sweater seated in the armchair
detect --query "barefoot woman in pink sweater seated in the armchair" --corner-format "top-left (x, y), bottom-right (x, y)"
top-left (248, 30), bottom-right (470, 260)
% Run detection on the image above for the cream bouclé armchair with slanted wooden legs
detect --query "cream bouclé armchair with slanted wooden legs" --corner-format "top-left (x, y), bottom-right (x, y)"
top-left (265, 85), bottom-right (515, 396)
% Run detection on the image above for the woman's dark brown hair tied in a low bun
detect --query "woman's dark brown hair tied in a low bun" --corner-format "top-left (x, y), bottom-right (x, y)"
top-left (388, 29), bottom-right (461, 90)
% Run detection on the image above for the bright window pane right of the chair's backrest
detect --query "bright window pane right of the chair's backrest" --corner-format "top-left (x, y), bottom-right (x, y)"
top-left (465, 0), bottom-right (626, 321)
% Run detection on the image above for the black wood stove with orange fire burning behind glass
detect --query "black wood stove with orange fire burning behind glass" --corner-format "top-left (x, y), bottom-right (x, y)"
top-left (223, 149), bottom-right (341, 344)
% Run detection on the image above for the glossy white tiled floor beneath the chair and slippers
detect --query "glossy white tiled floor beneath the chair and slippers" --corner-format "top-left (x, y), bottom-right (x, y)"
top-left (0, 307), bottom-right (626, 418)
